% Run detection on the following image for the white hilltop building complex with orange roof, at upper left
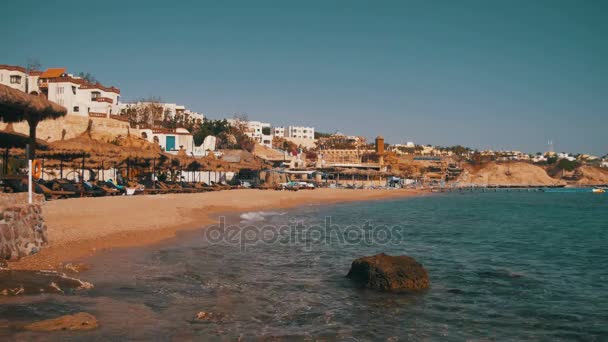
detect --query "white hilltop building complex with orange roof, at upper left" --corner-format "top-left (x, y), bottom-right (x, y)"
top-left (0, 65), bottom-right (120, 117)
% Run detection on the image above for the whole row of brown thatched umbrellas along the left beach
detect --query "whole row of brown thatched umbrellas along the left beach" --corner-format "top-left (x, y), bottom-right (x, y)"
top-left (0, 85), bottom-right (264, 182)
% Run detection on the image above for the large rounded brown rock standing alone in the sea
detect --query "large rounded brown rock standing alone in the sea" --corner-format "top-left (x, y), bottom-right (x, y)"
top-left (346, 253), bottom-right (429, 291)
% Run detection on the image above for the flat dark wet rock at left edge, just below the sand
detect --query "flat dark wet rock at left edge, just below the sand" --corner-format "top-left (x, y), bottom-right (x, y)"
top-left (0, 270), bottom-right (93, 296)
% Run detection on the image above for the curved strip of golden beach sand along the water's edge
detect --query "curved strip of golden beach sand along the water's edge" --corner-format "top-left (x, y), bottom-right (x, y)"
top-left (10, 189), bottom-right (424, 270)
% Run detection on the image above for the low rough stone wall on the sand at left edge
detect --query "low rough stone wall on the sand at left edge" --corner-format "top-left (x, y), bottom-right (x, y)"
top-left (0, 193), bottom-right (48, 261)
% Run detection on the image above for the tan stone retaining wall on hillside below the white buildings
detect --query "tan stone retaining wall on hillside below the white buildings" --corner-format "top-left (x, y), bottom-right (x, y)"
top-left (0, 115), bottom-right (132, 142)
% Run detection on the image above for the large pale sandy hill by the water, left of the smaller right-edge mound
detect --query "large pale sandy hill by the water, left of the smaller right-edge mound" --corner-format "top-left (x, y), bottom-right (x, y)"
top-left (458, 162), bottom-right (565, 185)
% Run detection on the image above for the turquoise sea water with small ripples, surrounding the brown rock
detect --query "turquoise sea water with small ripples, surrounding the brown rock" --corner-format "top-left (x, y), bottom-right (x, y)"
top-left (0, 192), bottom-right (608, 341)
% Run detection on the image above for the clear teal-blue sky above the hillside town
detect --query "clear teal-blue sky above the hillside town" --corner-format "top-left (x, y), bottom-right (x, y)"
top-left (0, 0), bottom-right (608, 155)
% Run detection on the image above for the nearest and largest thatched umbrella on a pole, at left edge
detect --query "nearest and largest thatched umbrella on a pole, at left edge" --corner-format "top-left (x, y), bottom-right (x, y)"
top-left (0, 84), bottom-right (67, 159)
